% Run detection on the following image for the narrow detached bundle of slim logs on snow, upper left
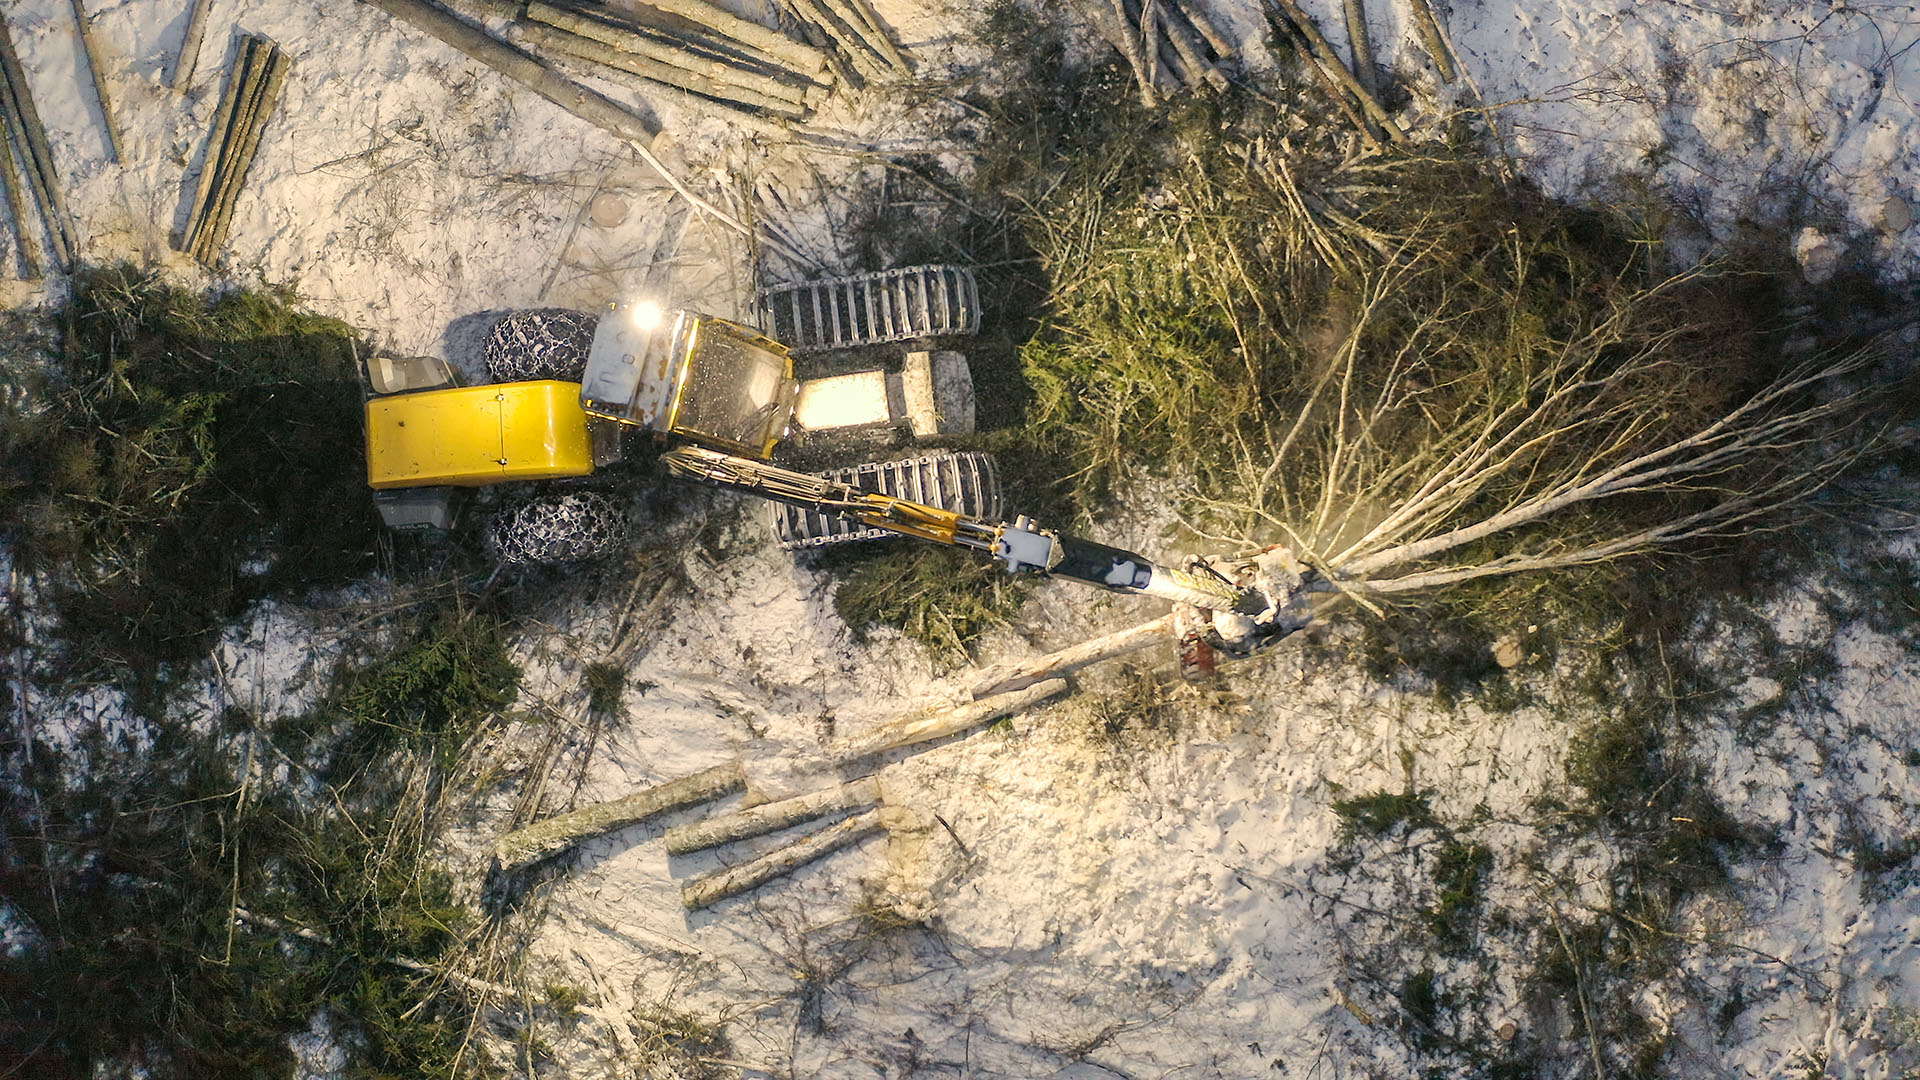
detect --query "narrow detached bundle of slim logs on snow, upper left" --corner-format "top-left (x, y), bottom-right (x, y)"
top-left (175, 35), bottom-right (292, 265)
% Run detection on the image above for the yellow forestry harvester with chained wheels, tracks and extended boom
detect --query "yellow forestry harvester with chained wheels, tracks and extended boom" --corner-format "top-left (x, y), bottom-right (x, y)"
top-left (367, 267), bottom-right (1292, 664)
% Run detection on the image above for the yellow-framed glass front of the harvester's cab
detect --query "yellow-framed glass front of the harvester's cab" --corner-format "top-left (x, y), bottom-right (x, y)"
top-left (674, 319), bottom-right (795, 457)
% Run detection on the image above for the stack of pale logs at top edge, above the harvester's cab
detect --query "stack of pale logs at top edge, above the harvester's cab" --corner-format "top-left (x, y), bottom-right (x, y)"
top-left (503, 0), bottom-right (910, 127)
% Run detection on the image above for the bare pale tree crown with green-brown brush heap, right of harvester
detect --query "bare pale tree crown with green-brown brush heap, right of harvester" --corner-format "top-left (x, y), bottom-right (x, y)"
top-left (1025, 106), bottom-right (1887, 614)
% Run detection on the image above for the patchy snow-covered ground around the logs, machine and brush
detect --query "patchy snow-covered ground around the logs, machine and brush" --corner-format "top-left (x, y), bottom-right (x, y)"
top-left (0, 0), bottom-right (1920, 1078)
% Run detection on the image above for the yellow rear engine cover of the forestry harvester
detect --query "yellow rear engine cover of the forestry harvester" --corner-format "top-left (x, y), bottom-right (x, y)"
top-left (367, 380), bottom-right (593, 490)
